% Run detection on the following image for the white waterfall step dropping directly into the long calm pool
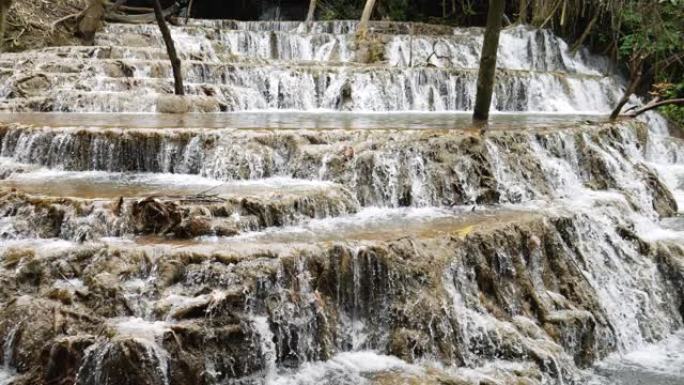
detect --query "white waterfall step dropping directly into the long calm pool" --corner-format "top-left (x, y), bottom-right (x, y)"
top-left (0, 58), bottom-right (621, 112)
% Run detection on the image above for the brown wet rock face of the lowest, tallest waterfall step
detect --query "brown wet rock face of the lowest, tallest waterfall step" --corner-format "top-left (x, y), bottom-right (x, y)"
top-left (0, 210), bottom-right (684, 384)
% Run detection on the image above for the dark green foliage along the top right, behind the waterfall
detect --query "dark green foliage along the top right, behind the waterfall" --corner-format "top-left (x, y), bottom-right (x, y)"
top-left (319, 0), bottom-right (684, 124)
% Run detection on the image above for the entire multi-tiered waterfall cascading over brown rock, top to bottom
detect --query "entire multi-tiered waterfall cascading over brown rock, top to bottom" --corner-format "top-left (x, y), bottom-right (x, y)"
top-left (0, 20), bottom-right (684, 385)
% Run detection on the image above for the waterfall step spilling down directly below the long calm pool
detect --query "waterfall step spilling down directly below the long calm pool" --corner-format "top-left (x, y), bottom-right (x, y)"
top-left (0, 115), bottom-right (673, 214)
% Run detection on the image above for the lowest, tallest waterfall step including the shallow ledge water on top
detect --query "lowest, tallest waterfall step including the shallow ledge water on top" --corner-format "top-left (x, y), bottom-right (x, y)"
top-left (0, 200), bottom-right (682, 385)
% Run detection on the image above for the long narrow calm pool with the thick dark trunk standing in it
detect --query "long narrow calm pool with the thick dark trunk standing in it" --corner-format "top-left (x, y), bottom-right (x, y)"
top-left (0, 111), bottom-right (606, 130)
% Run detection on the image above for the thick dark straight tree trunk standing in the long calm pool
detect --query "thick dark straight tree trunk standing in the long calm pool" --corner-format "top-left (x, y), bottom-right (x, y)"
top-left (473, 0), bottom-right (506, 122)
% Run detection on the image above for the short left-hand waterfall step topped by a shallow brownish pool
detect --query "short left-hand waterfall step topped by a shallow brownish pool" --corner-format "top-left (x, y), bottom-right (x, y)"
top-left (0, 170), bottom-right (359, 241)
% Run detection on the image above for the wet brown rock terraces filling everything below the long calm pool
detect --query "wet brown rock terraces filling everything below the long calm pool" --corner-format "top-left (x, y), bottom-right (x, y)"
top-left (0, 118), bottom-right (684, 384)
